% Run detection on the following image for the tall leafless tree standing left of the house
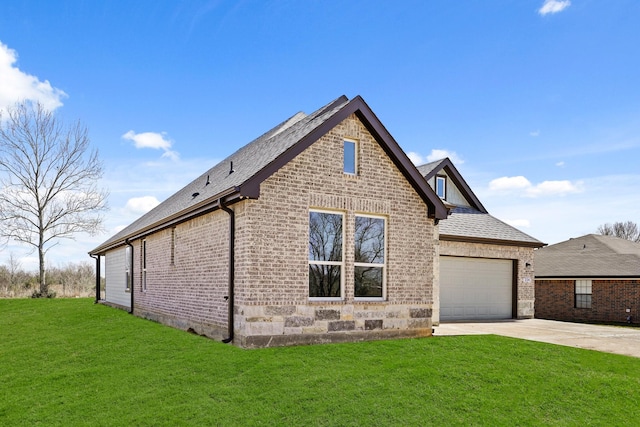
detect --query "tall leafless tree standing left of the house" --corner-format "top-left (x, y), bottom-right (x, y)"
top-left (0, 102), bottom-right (107, 297)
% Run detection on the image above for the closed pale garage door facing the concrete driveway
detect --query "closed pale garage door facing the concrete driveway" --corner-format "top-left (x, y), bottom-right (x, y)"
top-left (440, 256), bottom-right (513, 321)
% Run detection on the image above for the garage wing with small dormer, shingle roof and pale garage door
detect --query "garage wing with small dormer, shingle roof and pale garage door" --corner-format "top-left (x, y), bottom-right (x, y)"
top-left (418, 158), bottom-right (544, 324)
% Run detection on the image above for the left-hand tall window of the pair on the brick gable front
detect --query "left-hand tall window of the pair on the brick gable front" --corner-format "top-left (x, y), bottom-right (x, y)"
top-left (309, 211), bottom-right (344, 299)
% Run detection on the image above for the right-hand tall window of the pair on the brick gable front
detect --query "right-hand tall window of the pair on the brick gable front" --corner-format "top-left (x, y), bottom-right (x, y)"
top-left (354, 215), bottom-right (386, 299)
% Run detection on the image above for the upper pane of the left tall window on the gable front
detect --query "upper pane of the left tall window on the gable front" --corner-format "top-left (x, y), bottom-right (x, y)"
top-left (309, 212), bottom-right (342, 261)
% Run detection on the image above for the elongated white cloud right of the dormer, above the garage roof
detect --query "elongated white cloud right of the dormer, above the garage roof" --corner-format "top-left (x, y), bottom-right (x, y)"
top-left (489, 176), bottom-right (583, 197)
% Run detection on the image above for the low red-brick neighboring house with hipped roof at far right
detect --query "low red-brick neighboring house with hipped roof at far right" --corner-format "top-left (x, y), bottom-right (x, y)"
top-left (535, 234), bottom-right (640, 323)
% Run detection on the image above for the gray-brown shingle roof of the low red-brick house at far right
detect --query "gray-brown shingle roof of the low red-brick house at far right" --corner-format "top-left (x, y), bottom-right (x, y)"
top-left (534, 234), bottom-right (640, 278)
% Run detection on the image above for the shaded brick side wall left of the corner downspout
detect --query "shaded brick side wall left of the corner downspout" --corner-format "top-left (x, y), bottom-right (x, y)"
top-left (132, 211), bottom-right (229, 338)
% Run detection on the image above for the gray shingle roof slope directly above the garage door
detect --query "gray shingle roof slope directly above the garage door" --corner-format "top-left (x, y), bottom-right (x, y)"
top-left (440, 207), bottom-right (543, 247)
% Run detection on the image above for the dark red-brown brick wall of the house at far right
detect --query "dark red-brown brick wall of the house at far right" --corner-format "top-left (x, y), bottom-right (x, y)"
top-left (536, 279), bottom-right (640, 323)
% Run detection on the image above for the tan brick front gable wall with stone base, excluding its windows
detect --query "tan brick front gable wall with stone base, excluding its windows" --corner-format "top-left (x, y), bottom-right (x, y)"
top-left (235, 115), bottom-right (435, 347)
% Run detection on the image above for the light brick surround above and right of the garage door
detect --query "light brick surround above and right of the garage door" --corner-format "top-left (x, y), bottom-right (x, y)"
top-left (440, 240), bottom-right (535, 319)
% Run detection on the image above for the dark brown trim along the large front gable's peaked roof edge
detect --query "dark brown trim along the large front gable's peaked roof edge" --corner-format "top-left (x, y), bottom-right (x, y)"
top-left (240, 95), bottom-right (448, 219)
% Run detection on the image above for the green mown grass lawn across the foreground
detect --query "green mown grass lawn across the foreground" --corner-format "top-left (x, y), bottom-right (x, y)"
top-left (0, 299), bottom-right (640, 426)
